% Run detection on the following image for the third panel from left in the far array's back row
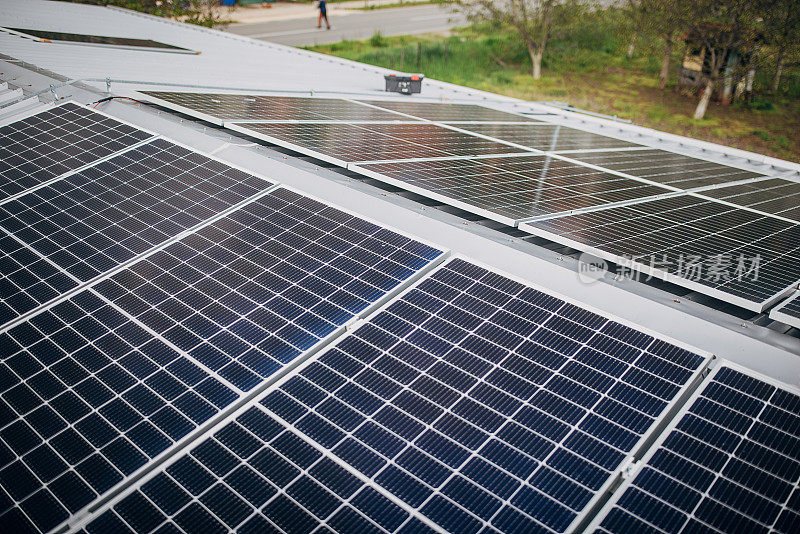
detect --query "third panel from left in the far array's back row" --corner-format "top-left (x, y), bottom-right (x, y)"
top-left (570, 149), bottom-right (761, 189)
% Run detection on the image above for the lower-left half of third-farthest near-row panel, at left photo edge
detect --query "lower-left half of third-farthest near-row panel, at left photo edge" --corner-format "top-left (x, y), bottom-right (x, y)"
top-left (0, 290), bottom-right (237, 532)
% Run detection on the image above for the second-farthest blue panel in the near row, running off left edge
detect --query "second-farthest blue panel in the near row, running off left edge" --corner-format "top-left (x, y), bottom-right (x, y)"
top-left (0, 139), bottom-right (273, 324)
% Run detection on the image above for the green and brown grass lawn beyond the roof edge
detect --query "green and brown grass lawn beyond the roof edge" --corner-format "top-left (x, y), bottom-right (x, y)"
top-left (309, 10), bottom-right (800, 161)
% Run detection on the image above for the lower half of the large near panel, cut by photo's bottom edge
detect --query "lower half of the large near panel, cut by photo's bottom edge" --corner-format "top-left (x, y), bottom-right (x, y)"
top-left (86, 405), bottom-right (433, 534)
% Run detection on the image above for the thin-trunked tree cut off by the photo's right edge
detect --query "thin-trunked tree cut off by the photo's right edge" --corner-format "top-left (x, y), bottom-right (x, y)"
top-left (761, 0), bottom-right (800, 93)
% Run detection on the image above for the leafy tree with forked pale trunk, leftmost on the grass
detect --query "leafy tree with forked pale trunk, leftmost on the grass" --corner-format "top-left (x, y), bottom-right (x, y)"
top-left (454, 0), bottom-right (583, 80)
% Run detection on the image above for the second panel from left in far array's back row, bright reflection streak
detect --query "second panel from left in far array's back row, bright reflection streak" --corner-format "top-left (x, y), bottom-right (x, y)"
top-left (446, 123), bottom-right (640, 154)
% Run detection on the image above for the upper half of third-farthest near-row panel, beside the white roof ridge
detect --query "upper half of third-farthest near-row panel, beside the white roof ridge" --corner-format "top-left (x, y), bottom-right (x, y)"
top-left (95, 188), bottom-right (442, 390)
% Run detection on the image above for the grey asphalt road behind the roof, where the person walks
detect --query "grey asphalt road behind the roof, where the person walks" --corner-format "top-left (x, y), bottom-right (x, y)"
top-left (228, 4), bottom-right (465, 46)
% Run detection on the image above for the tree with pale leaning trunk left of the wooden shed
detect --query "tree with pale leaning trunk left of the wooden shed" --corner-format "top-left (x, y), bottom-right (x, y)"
top-left (689, 0), bottom-right (760, 119)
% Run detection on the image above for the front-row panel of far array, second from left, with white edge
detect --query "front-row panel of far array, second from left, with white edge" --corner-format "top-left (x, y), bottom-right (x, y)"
top-left (227, 122), bottom-right (524, 166)
